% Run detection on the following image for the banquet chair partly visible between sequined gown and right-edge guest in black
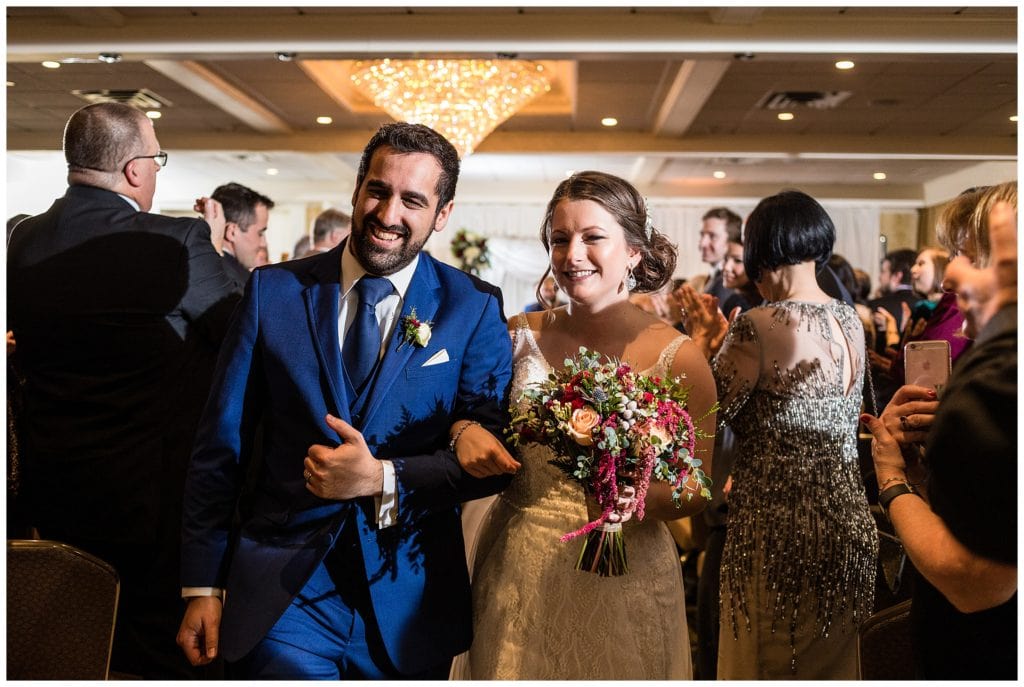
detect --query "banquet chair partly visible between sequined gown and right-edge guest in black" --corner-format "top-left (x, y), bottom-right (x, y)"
top-left (857, 600), bottom-right (914, 680)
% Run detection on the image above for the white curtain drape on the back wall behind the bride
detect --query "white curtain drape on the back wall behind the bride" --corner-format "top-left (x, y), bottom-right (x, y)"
top-left (426, 199), bottom-right (881, 315)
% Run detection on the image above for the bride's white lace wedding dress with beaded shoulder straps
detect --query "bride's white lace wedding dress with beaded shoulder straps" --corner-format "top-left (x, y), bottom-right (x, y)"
top-left (453, 316), bottom-right (692, 680)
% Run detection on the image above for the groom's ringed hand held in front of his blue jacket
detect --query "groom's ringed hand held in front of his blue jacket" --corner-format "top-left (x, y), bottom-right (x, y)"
top-left (303, 415), bottom-right (384, 501)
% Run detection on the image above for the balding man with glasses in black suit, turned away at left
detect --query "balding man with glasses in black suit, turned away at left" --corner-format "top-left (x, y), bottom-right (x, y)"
top-left (7, 102), bottom-right (239, 679)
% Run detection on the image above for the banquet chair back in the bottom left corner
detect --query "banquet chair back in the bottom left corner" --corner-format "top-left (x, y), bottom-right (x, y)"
top-left (7, 540), bottom-right (120, 680)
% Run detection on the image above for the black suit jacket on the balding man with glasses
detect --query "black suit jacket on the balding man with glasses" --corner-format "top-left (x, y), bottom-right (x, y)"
top-left (7, 185), bottom-right (239, 575)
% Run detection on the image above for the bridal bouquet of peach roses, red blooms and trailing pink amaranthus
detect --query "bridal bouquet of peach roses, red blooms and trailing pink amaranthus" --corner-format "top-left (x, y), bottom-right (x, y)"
top-left (509, 347), bottom-right (715, 576)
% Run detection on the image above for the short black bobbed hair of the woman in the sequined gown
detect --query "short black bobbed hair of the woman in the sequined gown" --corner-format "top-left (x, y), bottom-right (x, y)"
top-left (743, 190), bottom-right (836, 282)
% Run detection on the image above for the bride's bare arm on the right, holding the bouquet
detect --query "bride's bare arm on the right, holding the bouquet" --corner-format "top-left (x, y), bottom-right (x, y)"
top-left (644, 341), bottom-right (721, 520)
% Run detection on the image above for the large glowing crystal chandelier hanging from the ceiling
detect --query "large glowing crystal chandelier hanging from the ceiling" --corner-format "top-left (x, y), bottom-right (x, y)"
top-left (351, 59), bottom-right (551, 158)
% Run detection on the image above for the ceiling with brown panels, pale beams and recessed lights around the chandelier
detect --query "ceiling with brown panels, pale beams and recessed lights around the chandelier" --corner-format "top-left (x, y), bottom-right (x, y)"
top-left (6, 3), bottom-right (1018, 210)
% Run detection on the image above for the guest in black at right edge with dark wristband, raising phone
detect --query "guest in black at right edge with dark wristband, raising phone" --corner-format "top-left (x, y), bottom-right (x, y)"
top-left (862, 183), bottom-right (1018, 680)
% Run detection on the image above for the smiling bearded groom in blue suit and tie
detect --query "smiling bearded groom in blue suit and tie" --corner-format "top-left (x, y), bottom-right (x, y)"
top-left (178, 123), bottom-right (511, 680)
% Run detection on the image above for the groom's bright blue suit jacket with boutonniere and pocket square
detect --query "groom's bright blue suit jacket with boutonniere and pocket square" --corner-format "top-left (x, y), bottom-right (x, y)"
top-left (181, 243), bottom-right (511, 673)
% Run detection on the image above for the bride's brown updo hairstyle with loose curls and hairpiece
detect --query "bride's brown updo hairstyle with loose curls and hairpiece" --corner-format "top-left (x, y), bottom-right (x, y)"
top-left (538, 171), bottom-right (676, 303)
